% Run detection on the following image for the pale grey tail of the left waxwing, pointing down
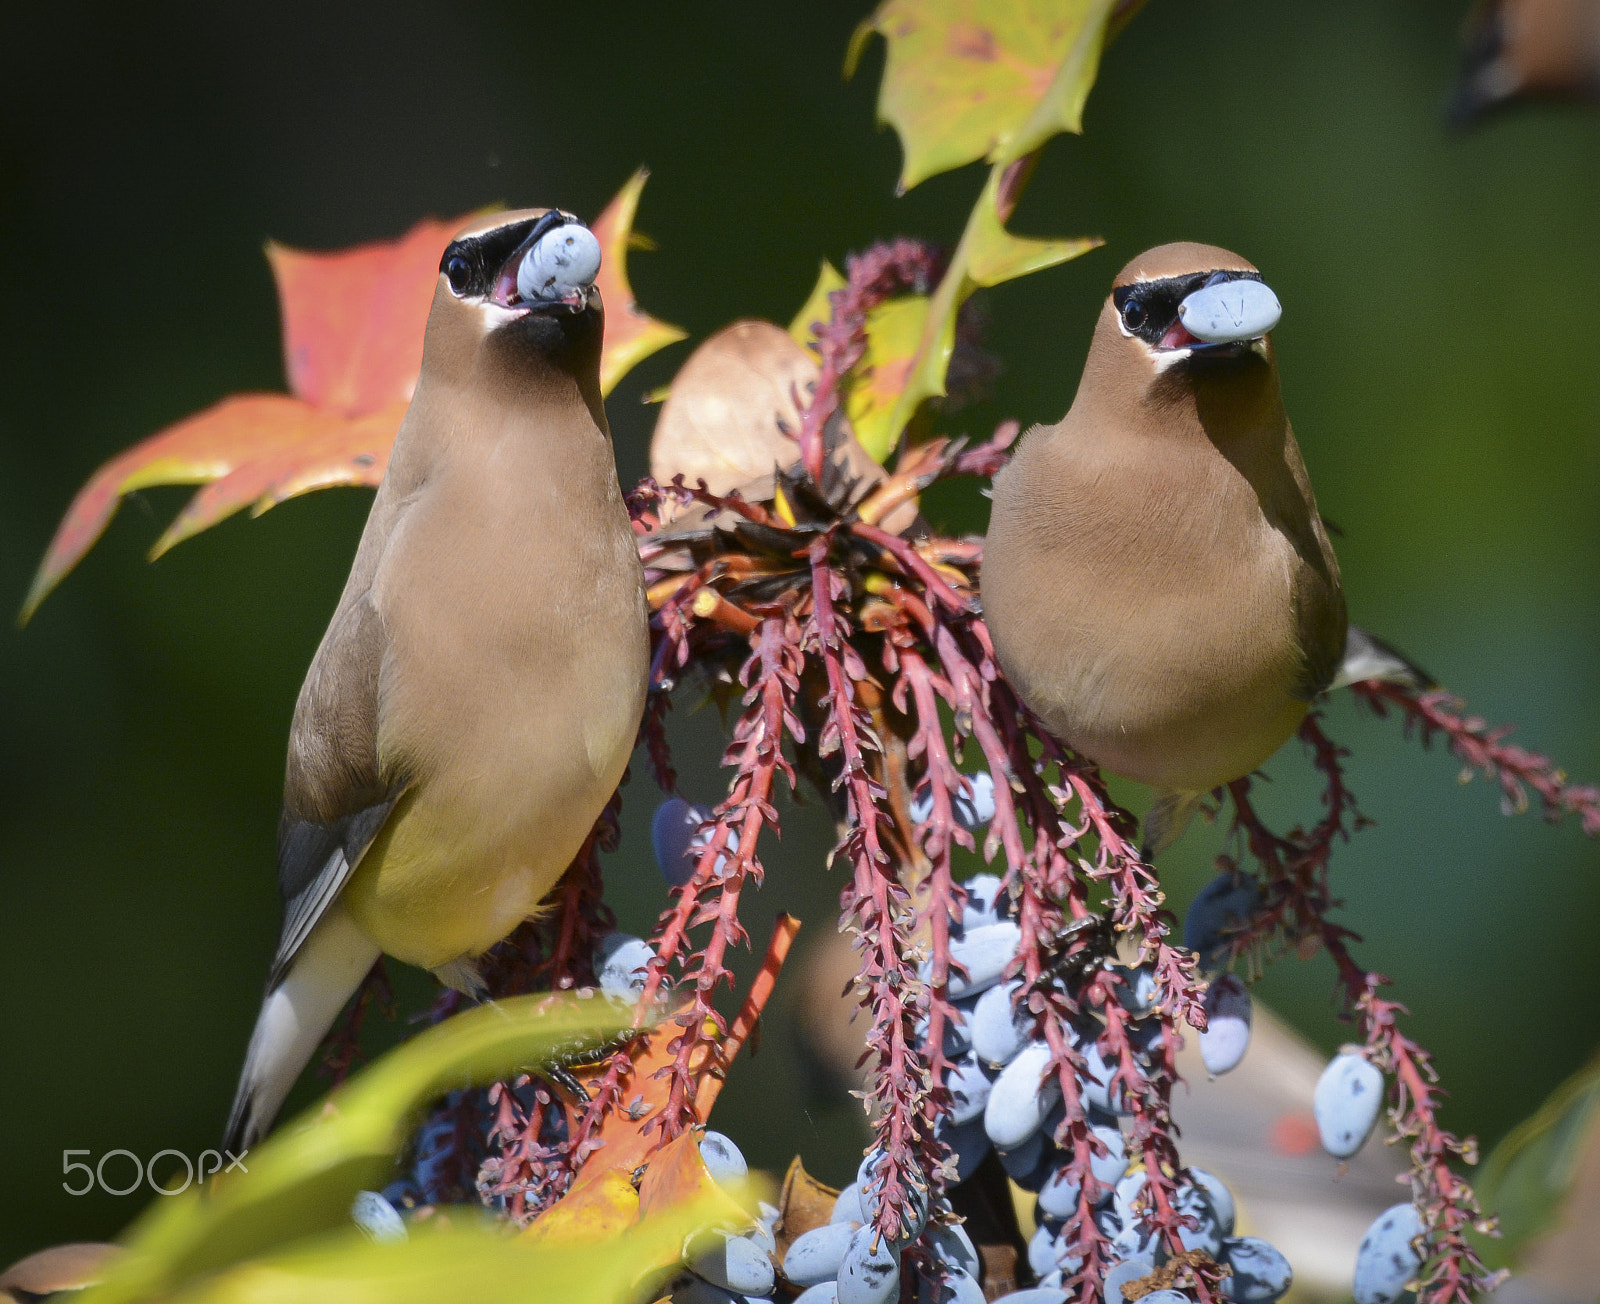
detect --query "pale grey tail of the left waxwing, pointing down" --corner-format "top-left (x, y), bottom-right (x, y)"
top-left (222, 901), bottom-right (379, 1155)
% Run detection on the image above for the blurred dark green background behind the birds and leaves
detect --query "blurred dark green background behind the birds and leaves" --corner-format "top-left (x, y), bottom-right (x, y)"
top-left (0, 0), bottom-right (1600, 1262)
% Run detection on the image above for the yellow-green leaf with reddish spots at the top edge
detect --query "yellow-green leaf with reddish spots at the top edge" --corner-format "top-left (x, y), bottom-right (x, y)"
top-left (845, 0), bottom-right (1142, 190)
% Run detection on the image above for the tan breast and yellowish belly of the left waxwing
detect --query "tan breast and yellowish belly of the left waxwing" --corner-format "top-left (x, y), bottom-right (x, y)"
top-left (349, 437), bottom-right (648, 968)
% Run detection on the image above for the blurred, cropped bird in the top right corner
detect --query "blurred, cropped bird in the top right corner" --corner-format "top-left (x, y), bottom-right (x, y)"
top-left (1448, 0), bottom-right (1600, 126)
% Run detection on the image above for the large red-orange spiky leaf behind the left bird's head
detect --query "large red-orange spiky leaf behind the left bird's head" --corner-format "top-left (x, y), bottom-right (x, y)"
top-left (18, 170), bottom-right (683, 624)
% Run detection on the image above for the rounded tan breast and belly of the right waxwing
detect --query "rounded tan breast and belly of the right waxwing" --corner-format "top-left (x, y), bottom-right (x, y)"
top-left (982, 429), bottom-right (1314, 790)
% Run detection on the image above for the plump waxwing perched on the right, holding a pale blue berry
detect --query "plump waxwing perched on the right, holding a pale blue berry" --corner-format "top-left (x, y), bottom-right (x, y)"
top-left (982, 243), bottom-right (1346, 854)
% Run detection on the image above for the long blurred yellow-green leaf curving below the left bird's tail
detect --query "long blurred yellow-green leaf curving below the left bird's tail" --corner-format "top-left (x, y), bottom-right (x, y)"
top-left (83, 995), bottom-right (632, 1304)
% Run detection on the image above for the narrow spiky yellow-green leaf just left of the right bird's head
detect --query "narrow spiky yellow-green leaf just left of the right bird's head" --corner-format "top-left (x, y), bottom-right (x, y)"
top-left (877, 165), bottom-right (1101, 446)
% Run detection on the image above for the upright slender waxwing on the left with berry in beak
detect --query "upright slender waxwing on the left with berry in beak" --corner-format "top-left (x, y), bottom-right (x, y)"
top-left (227, 210), bottom-right (648, 1152)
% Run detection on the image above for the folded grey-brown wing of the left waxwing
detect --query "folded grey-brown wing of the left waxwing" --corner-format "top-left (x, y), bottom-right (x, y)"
top-left (267, 592), bottom-right (405, 990)
